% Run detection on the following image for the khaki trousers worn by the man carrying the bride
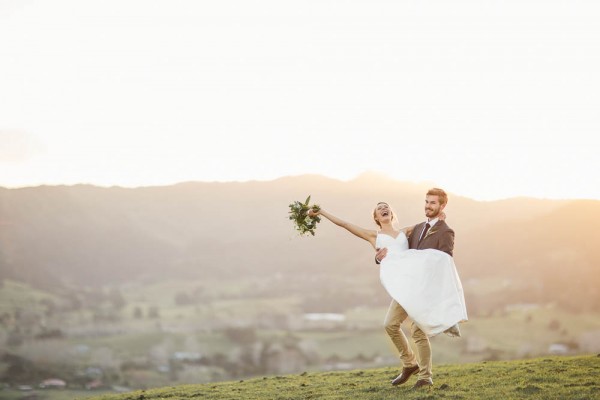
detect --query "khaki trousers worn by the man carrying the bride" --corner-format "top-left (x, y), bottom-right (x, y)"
top-left (384, 300), bottom-right (433, 380)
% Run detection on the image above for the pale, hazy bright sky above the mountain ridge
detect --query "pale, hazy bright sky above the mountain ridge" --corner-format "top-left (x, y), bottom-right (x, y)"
top-left (0, 0), bottom-right (600, 199)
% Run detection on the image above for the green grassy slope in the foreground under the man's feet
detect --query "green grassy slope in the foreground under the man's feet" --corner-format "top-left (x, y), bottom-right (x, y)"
top-left (85, 355), bottom-right (600, 400)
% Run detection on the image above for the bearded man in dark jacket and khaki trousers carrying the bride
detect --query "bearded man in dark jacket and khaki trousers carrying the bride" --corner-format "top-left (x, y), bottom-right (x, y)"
top-left (375, 188), bottom-right (460, 389)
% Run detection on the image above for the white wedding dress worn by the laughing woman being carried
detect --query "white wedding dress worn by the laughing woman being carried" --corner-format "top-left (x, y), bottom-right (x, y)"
top-left (375, 232), bottom-right (467, 336)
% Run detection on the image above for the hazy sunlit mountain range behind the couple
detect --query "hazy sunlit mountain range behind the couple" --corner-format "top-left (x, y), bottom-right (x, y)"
top-left (0, 173), bottom-right (600, 309)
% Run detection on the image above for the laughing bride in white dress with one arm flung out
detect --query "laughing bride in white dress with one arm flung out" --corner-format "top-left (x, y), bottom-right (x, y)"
top-left (308, 202), bottom-right (467, 337)
